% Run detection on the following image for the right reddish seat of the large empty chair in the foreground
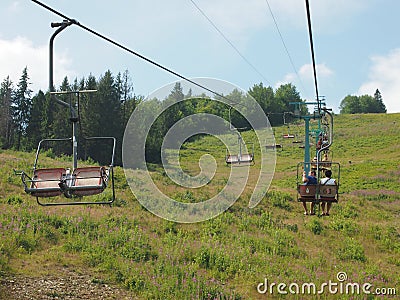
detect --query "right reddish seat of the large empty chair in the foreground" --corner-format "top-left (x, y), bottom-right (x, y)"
top-left (69, 167), bottom-right (108, 197)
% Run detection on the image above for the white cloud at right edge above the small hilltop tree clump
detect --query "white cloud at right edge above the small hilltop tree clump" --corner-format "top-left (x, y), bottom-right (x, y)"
top-left (358, 48), bottom-right (400, 113)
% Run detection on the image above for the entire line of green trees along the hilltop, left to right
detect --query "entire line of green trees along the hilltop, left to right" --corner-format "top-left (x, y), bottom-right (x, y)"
top-left (0, 68), bottom-right (386, 165)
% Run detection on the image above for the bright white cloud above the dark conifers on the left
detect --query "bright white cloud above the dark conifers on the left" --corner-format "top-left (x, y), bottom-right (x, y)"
top-left (0, 37), bottom-right (76, 92)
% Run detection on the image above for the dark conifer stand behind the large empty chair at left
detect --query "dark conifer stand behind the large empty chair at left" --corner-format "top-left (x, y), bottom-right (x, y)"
top-left (0, 68), bottom-right (143, 164)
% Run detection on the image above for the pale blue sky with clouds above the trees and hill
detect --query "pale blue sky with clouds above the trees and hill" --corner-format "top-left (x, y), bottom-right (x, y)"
top-left (0, 0), bottom-right (400, 112)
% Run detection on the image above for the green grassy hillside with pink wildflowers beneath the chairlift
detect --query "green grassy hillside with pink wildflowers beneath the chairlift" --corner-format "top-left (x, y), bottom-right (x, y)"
top-left (0, 114), bottom-right (400, 299)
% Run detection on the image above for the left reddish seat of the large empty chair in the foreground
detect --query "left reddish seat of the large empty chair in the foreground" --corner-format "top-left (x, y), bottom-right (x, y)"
top-left (25, 168), bottom-right (66, 197)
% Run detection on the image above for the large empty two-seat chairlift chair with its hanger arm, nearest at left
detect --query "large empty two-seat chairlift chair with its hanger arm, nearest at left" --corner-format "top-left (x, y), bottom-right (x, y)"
top-left (14, 20), bottom-right (116, 206)
